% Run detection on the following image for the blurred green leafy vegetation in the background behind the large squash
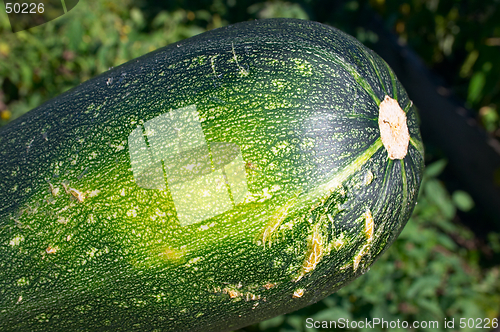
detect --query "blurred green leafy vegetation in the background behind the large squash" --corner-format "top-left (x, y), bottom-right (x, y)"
top-left (0, 0), bottom-right (500, 332)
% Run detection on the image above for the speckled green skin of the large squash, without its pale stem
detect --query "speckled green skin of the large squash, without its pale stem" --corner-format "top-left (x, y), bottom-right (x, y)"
top-left (0, 19), bottom-right (423, 331)
